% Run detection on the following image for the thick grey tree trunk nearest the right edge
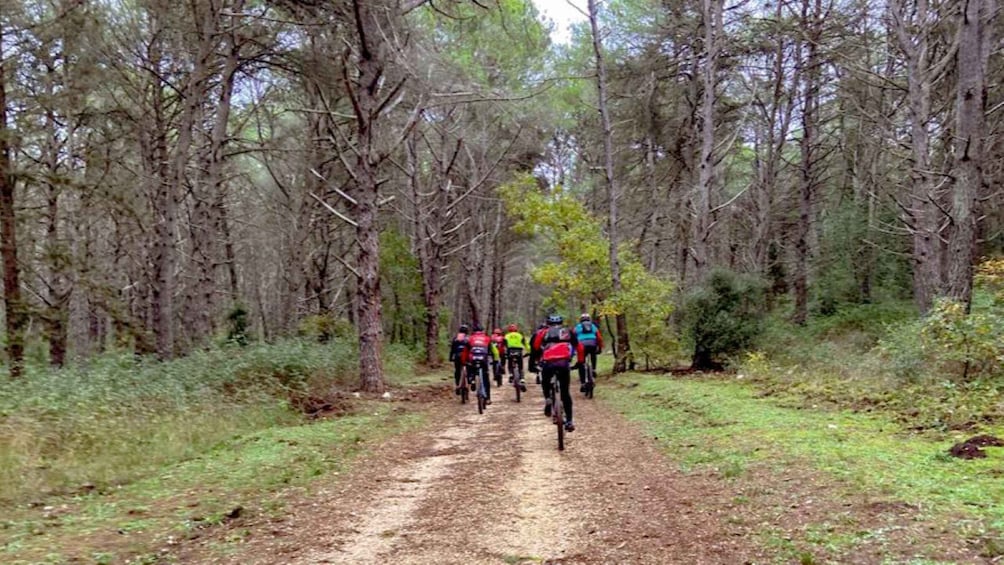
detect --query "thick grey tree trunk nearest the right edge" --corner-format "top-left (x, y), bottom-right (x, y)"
top-left (947, 0), bottom-right (996, 311)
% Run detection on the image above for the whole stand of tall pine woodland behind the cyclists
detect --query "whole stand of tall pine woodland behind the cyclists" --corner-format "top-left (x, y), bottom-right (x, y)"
top-left (0, 0), bottom-right (1004, 390)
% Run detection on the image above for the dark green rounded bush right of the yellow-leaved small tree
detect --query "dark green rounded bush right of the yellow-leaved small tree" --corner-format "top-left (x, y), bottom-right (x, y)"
top-left (684, 269), bottom-right (766, 369)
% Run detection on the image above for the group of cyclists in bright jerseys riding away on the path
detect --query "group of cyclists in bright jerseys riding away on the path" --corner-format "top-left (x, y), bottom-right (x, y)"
top-left (450, 314), bottom-right (603, 432)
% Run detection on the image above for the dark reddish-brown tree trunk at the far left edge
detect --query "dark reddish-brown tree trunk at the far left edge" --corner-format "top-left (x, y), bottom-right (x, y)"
top-left (0, 34), bottom-right (28, 378)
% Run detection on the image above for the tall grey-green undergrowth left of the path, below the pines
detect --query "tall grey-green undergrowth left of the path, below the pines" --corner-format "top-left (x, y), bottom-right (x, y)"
top-left (0, 340), bottom-right (414, 507)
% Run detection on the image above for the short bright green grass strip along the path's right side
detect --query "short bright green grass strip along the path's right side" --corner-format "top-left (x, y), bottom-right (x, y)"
top-left (600, 375), bottom-right (1004, 562)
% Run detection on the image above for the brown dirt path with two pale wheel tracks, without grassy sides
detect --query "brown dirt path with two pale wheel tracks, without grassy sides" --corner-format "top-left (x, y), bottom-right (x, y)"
top-left (186, 375), bottom-right (754, 564)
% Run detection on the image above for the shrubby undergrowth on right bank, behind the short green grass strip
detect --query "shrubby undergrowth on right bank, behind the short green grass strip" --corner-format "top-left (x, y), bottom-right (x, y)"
top-left (738, 302), bottom-right (1004, 431)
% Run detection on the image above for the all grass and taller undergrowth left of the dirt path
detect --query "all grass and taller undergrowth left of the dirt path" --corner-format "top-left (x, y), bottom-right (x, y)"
top-left (0, 340), bottom-right (436, 563)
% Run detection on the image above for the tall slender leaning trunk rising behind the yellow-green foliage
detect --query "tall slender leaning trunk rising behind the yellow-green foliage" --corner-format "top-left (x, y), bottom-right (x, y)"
top-left (588, 0), bottom-right (634, 372)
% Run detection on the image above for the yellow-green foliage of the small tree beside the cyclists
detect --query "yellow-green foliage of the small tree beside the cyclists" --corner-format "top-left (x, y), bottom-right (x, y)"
top-left (499, 176), bottom-right (679, 365)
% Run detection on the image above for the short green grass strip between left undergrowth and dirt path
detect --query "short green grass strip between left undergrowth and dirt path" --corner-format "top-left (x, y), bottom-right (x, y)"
top-left (0, 403), bottom-right (424, 564)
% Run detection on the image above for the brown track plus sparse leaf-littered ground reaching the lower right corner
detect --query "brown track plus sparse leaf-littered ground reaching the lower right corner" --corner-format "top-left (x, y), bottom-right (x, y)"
top-left (172, 371), bottom-right (999, 565)
